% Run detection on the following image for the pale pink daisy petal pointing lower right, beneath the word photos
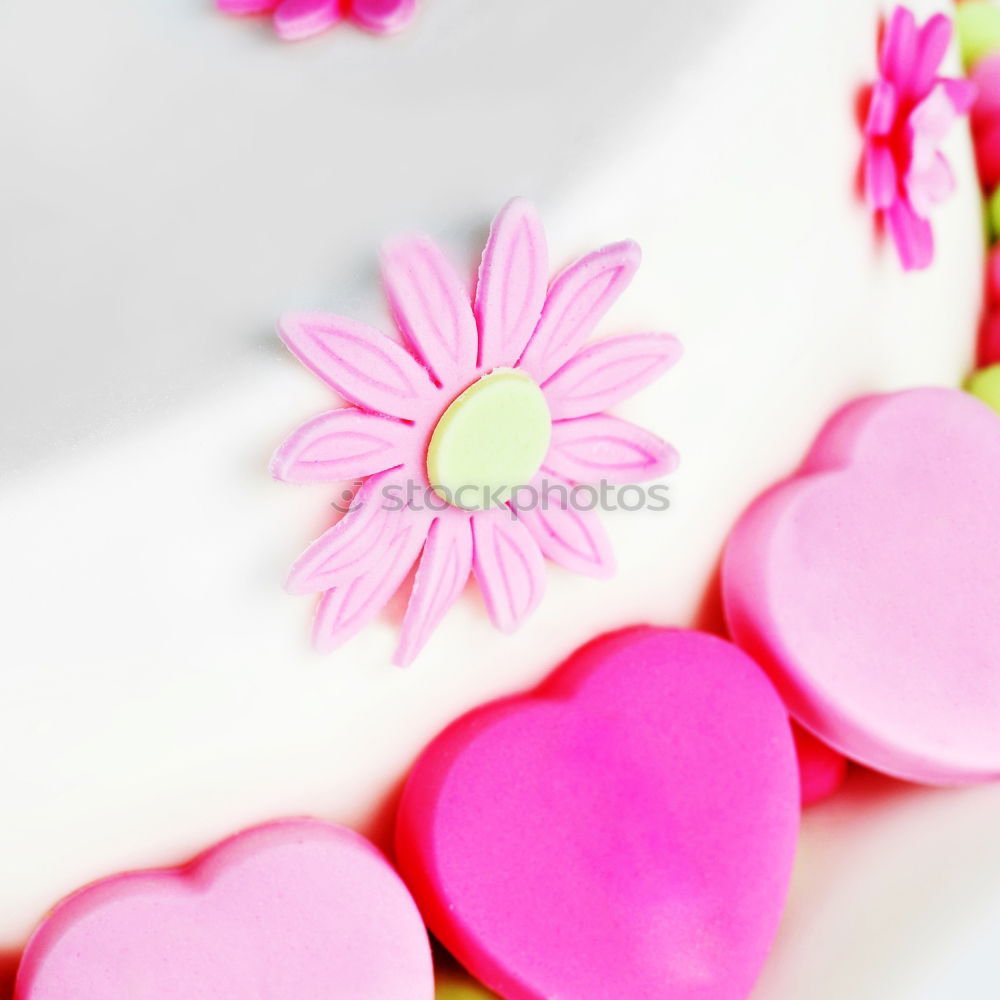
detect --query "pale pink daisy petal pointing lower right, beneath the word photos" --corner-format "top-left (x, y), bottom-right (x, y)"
top-left (512, 476), bottom-right (615, 578)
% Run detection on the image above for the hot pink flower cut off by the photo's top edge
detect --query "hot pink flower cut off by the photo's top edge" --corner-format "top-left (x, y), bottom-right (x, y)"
top-left (216, 0), bottom-right (416, 41)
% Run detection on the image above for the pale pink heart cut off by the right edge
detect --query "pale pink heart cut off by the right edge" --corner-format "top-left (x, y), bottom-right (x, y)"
top-left (723, 389), bottom-right (1000, 784)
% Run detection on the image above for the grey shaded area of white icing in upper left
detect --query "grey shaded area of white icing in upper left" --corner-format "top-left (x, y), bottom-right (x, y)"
top-left (0, 0), bottom-right (734, 475)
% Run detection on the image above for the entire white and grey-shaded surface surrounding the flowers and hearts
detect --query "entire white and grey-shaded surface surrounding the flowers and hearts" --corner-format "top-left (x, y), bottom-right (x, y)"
top-left (0, 0), bottom-right (1000, 1000)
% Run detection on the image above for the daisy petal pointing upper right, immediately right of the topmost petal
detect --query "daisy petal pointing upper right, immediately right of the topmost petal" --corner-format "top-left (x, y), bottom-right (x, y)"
top-left (520, 241), bottom-right (642, 382)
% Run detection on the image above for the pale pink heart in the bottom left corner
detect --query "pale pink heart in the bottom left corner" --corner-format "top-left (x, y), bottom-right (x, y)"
top-left (15, 820), bottom-right (434, 1000)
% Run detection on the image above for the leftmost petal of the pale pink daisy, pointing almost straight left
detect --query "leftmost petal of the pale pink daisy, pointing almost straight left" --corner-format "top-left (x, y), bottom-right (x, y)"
top-left (271, 406), bottom-right (410, 483)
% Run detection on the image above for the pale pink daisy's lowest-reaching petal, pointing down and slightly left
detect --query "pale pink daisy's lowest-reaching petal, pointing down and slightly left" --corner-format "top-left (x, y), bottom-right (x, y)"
top-left (395, 514), bottom-right (472, 667)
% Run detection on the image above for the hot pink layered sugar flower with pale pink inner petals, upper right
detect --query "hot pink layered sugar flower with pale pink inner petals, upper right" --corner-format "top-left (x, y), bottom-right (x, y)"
top-left (864, 7), bottom-right (975, 271)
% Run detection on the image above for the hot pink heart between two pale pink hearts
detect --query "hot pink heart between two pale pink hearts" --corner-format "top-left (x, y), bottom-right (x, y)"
top-left (396, 628), bottom-right (799, 1000)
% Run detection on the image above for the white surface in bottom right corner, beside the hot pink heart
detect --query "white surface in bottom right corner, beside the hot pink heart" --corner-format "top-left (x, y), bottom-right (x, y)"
top-left (753, 769), bottom-right (1000, 1000)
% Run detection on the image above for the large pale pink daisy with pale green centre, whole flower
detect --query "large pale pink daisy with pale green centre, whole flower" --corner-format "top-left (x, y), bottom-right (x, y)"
top-left (272, 199), bottom-right (680, 665)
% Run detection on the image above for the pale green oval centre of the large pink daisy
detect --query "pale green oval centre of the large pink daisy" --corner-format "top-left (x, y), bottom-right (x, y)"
top-left (427, 368), bottom-right (552, 510)
